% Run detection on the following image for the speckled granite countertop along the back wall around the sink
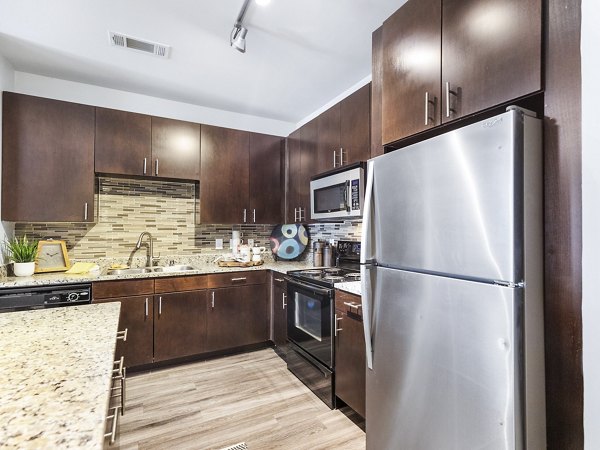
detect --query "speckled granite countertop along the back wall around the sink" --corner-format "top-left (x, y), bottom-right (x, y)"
top-left (0, 255), bottom-right (312, 288)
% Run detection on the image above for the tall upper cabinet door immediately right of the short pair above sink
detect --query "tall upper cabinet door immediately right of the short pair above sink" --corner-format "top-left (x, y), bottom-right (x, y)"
top-left (200, 125), bottom-right (250, 224)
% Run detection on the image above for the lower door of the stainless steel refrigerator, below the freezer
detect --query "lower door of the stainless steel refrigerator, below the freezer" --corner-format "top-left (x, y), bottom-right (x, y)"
top-left (367, 267), bottom-right (523, 450)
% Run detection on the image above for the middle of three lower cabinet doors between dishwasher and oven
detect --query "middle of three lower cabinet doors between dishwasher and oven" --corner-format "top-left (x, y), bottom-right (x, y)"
top-left (154, 291), bottom-right (207, 361)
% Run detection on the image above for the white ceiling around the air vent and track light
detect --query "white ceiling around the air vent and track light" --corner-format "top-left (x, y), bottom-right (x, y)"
top-left (0, 0), bottom-right (406, 122)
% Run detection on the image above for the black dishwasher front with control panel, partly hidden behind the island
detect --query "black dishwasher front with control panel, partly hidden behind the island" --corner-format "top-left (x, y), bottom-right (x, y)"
top-left (0, 283), bottom-right (92, 313)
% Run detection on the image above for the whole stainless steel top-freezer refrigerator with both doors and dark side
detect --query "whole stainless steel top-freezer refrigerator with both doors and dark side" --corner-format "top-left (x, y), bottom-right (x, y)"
top-left (361, 108), bottom-right (546, 450)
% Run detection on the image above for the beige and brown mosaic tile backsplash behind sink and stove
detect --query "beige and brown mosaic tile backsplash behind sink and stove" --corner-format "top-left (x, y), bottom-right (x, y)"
top-left (15, 178), bottom-right (361, 260)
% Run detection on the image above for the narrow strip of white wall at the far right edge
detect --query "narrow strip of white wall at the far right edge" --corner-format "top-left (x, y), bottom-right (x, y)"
top-left (581, 0), bottom-right (600, 450)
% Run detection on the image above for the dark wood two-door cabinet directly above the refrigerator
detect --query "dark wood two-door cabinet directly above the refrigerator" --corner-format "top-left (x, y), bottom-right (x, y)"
top-left (382, 0), bottom-right (542, 144)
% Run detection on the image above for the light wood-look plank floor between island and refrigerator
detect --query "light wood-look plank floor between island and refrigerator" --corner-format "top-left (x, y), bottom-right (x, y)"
top-left (111, 349), bottom-right (365, 450)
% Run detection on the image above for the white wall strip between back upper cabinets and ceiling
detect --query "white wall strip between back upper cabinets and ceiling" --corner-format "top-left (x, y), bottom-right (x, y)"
top-left (14, 72), bottom-right (295, 136)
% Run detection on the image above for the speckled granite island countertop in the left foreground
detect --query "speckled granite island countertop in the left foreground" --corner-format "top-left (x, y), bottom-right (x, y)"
top-left (0, 302), bottom-right (121, 449)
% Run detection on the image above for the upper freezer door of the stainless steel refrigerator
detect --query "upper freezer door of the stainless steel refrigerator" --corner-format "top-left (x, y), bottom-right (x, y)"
top-left (367, 111), bottom-right (523, 282)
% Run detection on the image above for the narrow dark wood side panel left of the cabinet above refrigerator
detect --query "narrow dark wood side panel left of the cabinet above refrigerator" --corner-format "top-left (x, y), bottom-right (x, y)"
top-left (371, 26), bottom-right (384, 158)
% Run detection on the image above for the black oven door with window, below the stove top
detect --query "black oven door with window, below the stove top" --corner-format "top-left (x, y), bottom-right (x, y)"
top-left (287, 279), bottom-right (333, 368)
